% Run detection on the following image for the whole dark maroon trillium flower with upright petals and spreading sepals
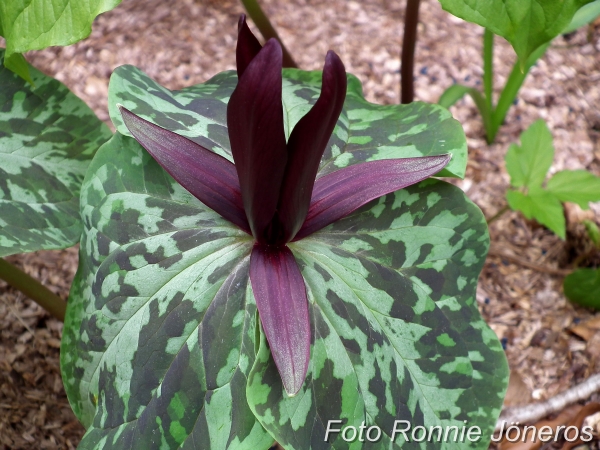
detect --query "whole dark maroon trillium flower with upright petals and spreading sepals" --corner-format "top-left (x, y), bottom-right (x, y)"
top-left (120, 16), bottom-right (450, 395)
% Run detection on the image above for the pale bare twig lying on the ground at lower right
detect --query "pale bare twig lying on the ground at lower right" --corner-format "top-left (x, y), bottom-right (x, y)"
top-left (496, 374), bottom-right (600, 431)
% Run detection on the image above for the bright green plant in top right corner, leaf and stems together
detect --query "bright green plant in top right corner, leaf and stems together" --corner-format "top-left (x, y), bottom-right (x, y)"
top-left (438, 0), bottom-right (600, 143)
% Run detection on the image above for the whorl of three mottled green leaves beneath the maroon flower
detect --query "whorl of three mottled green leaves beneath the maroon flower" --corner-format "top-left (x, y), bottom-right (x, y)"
top-left (67, 61), bottom-right (507, 450)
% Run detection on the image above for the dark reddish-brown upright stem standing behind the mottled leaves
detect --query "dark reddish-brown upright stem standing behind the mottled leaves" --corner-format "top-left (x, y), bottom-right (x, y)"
top-left (400, 0), bottom-right (421, 104)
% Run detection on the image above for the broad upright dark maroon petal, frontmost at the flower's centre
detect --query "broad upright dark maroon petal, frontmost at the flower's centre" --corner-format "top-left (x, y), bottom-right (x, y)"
top-left (227, 39), bottom-right (287, 242)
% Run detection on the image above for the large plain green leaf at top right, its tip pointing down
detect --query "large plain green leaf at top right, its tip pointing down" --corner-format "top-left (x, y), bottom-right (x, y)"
top-left (440, 0), bottom-right (593, 65)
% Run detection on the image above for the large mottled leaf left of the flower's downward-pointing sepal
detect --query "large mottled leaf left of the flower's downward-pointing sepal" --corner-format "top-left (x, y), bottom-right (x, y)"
top-left (61, 133), bottom-right (273, 450)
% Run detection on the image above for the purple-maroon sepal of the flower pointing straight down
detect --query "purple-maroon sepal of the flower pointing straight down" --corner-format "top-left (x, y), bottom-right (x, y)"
top-left (250, 243), bottom-right (310, 396)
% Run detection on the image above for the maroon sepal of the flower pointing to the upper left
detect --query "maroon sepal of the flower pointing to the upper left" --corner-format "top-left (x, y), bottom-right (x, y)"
top-left (119, 106), bottom-right (250, 232)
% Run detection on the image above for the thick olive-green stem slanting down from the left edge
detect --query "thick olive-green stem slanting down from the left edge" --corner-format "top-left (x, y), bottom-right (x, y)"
top-left (0, 258), bottom-right (67, 322)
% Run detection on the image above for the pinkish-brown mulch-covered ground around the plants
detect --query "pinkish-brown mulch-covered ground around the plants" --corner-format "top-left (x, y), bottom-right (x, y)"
top-left (0, 0), bottom-right (600, 449)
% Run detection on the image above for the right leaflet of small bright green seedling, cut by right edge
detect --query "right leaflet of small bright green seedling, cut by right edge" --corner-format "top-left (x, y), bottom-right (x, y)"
top-left (546, 170), bottom-right (600, 209)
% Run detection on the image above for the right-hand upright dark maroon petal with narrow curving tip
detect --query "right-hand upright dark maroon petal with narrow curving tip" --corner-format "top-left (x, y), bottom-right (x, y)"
top-left (278, 51), bottom-right (347, 242)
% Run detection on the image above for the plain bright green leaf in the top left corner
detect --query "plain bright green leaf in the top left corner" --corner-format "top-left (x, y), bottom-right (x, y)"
top-left (0, 0), bottom-right (121, 57)
